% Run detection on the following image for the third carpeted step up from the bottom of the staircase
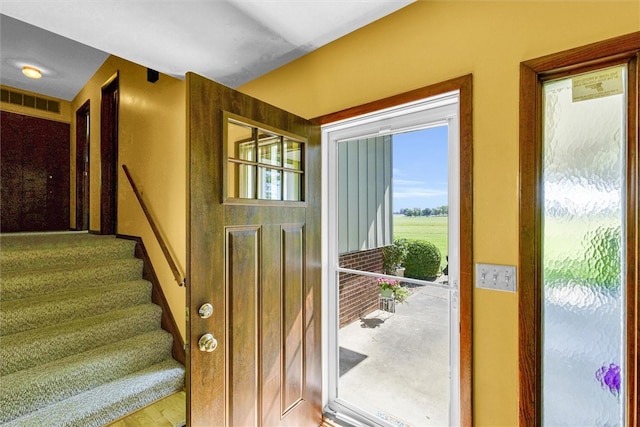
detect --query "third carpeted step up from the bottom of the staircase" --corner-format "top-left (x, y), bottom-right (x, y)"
top-left (0, 303), bottom-right (162, 375)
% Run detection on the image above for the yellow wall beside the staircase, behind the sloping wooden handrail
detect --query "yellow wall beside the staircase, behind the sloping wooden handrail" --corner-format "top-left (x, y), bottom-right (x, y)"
top-left (71, 56), bottom-right (186, 338)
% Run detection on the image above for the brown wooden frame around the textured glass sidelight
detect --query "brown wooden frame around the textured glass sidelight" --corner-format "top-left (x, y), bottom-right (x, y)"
top-left (518, 32), bottom-right (640, 426)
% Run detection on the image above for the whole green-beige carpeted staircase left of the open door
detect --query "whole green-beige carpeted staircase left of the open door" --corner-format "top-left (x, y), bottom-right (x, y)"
top-left (0, 233), bottom-right (184, 427)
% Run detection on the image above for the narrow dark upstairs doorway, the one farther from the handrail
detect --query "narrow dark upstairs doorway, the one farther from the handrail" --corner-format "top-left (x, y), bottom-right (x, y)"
top-left (75, 100), bottom-right (91, 231)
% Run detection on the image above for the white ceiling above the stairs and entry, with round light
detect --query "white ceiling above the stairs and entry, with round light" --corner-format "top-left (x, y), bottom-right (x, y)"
top-left (0, 0), bottom-right (415, 100)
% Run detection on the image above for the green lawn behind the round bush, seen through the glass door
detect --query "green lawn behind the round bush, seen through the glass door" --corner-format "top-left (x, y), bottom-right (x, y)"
top-left (393, 215), bottom-right (449, 265)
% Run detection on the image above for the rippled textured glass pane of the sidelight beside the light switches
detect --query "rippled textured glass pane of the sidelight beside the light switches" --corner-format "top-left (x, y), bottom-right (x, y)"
top-left (542, 67), bottom-right (626, 426)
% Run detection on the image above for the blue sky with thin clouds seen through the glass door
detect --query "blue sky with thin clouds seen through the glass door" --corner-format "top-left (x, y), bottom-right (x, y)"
top-left (393, 126), bottom-right (448, 212)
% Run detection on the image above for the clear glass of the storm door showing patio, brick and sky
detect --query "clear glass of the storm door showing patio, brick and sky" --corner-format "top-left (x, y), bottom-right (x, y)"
top-left (337, 126), bottom-right (451, 426)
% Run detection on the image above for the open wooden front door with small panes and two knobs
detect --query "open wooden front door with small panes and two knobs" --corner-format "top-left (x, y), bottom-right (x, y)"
top-left (187, 74), bottom-right (322, 427)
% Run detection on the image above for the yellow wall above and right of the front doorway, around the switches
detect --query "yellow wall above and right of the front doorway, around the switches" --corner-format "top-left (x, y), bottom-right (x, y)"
top-left (240, 0), bottom-right (640, 426)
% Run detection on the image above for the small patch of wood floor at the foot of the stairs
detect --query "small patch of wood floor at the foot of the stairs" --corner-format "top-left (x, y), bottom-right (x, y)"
top-left (108, 391), bottom-right (187, 427)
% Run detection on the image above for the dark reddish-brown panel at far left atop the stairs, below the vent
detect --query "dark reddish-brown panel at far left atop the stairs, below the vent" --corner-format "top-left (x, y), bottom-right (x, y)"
top-left (0, 111), bottom-right (70, 232)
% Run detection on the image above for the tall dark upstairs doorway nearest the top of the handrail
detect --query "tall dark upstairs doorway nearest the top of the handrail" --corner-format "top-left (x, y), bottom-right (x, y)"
top-left (100, 74), bottom-right (120, 234)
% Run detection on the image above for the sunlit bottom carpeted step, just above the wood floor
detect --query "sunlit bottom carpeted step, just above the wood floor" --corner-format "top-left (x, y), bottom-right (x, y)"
top-left (6, 359), bottom-right (184, 427)
